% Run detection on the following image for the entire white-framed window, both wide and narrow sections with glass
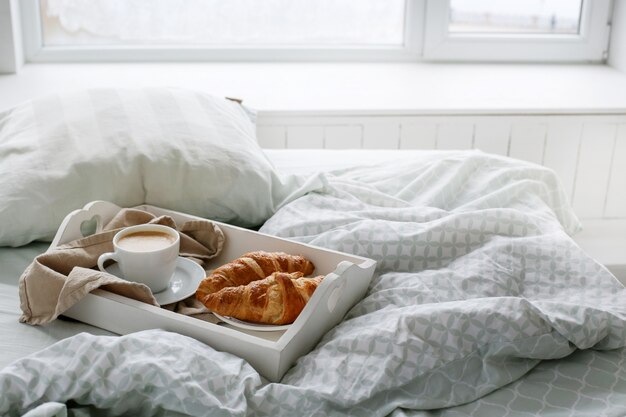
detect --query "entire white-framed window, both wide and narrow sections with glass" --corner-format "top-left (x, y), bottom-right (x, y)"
top-left (20, 0), bottom-right (610, 62)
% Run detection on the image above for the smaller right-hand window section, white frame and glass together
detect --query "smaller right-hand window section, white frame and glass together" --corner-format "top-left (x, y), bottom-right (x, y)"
top-left (423, 0), bottom-right (611, 62)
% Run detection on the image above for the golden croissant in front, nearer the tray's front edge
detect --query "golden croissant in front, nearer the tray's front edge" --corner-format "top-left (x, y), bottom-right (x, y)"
top-left (201, 272), bottom-right (324, 325)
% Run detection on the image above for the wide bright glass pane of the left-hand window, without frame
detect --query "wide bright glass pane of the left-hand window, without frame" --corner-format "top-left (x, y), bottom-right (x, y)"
top-left (40, 0), bottom-right (405, 46)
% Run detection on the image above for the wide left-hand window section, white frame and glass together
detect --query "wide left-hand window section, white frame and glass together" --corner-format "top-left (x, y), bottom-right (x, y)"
top-left (22, 0), bottom-right (424, 61)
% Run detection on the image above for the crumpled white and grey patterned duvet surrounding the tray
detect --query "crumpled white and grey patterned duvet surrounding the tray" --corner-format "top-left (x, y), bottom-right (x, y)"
top-left (0, 152), bottom-right (626, 416)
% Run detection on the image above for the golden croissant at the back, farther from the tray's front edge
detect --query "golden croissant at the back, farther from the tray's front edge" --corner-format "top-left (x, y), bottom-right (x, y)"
top-left (196, 251), bottom-right (315, 300)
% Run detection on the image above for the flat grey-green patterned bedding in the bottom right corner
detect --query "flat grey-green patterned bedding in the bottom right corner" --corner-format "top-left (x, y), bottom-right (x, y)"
top-left (408, 349), bottom-right (626, 417)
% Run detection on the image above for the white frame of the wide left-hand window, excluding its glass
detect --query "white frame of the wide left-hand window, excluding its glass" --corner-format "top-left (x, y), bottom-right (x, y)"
top-left (20, 0), bottom-right (426, 62)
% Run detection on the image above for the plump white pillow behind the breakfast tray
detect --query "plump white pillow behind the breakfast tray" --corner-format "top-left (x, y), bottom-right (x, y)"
top-left (0, 88), bottom-right (320, 246)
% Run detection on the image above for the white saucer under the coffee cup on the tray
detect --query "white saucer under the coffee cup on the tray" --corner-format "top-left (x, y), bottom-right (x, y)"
top-left (105, 257), bottom-right (205, 305)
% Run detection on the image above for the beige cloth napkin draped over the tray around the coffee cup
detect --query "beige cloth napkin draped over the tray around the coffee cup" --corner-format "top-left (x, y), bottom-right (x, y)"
top-left (19, 209), bottom-right (224, 324)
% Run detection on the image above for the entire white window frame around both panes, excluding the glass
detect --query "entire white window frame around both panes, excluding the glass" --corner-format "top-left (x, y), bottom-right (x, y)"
top-left (12, 0), bottom-right (612, 63)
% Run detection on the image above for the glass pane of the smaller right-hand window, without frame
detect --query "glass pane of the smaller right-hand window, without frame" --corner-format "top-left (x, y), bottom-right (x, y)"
top-left (448, 0), bottom-right (582, 34)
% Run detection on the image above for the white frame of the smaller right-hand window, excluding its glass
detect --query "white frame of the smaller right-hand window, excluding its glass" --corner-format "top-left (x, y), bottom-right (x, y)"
top-left (423, 0), bottom-right (612, 63)
